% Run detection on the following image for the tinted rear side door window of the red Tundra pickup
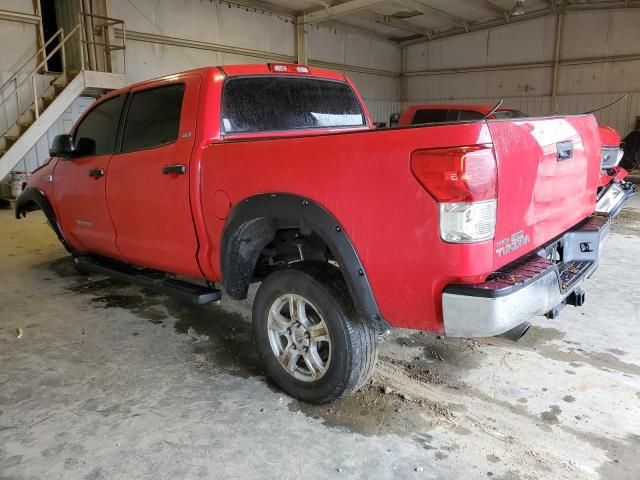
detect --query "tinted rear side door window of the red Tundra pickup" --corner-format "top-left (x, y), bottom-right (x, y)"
top-left (122, 83), bottom-right (184, 153)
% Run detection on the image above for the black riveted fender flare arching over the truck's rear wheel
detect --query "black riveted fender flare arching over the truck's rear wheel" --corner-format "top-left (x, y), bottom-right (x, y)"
top-left (220, 193), bottom-right (389, 331)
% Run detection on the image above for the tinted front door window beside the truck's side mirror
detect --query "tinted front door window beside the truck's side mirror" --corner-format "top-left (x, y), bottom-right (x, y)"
top-left (73, 95), bottom-right (124, 157)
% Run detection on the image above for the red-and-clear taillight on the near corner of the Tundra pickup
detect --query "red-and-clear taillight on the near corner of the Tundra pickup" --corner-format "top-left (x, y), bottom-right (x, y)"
top-left (411, 145), bottom-right (498, 243)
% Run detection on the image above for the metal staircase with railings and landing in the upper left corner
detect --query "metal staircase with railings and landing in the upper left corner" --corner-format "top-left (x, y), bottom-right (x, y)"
top-left (0, 13), bottom-right (126, 180)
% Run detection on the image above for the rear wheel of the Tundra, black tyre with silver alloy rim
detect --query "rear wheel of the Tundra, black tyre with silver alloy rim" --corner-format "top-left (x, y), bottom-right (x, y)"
top-left (253, 265), bottom-right (378, 403)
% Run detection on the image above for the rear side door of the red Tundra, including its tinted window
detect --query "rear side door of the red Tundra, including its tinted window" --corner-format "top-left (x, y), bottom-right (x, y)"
top-left (107, 75), bottom-right (202, 277)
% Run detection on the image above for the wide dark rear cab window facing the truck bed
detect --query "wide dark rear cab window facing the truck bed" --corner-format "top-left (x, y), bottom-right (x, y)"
top-left (222, 76), bottom-right (366, 133)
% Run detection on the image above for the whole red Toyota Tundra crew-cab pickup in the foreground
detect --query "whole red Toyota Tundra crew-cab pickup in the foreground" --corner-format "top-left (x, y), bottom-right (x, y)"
top-left (16, 64), bottom-right (626, 402)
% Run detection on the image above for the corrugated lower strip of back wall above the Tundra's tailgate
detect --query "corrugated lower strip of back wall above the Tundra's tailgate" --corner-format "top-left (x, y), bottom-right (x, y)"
top-left (405, 92), bottom-right (640, 137)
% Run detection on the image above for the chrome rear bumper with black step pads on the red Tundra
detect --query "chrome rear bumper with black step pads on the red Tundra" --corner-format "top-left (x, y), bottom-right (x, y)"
top-left (442, 214), bottom-right (610, 337)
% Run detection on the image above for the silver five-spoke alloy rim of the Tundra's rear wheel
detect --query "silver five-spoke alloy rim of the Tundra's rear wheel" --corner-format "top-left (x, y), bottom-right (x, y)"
top-left (267, 293), bottom-right (331, 382)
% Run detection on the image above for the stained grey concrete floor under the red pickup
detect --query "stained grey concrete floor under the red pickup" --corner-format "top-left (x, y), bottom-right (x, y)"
top-left (0, 200), bottom-right (640, 480)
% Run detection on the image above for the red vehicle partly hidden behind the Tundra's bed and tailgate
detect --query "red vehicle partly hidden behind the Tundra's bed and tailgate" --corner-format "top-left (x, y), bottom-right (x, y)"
top-left (398, 104), bottom-right (636, 217)
